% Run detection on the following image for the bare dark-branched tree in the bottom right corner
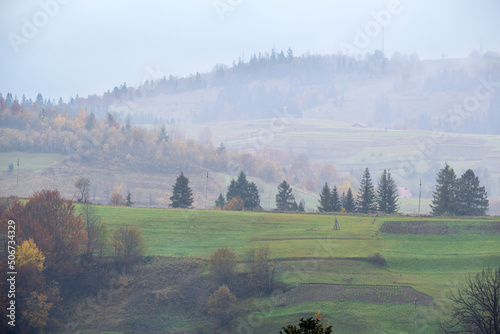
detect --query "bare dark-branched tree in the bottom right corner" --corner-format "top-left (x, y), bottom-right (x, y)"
top-left (439, 268), bottom-right (500, 334)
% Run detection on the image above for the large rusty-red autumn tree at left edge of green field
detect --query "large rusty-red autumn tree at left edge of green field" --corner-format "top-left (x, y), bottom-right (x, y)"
top-left (9, 190), bottom-right (87, 272)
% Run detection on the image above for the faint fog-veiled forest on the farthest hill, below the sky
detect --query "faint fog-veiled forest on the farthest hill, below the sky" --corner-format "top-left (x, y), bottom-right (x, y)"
top-left (0, 49), bottom-right (500, 134)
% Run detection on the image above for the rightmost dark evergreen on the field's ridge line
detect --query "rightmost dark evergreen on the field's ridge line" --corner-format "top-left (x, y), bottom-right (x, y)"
top-left (456, 169), bottom-right (489, 216)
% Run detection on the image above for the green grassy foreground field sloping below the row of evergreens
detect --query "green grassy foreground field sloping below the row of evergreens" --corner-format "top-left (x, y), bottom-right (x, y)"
top-left (83, 207), bottom-right (500, 333)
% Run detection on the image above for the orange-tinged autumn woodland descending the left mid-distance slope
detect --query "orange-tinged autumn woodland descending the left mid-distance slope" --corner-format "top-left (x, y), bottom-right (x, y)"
top-left (0, 102), bottom-right (358, 191)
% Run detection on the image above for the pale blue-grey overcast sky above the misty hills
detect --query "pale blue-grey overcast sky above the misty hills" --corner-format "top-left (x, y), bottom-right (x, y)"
top-left (0, 0), bottom-right (500, 101)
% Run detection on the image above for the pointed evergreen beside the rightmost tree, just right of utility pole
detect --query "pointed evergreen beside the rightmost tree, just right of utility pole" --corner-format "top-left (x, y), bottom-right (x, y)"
top-left (431, 163), bottom-right (457, 216)
